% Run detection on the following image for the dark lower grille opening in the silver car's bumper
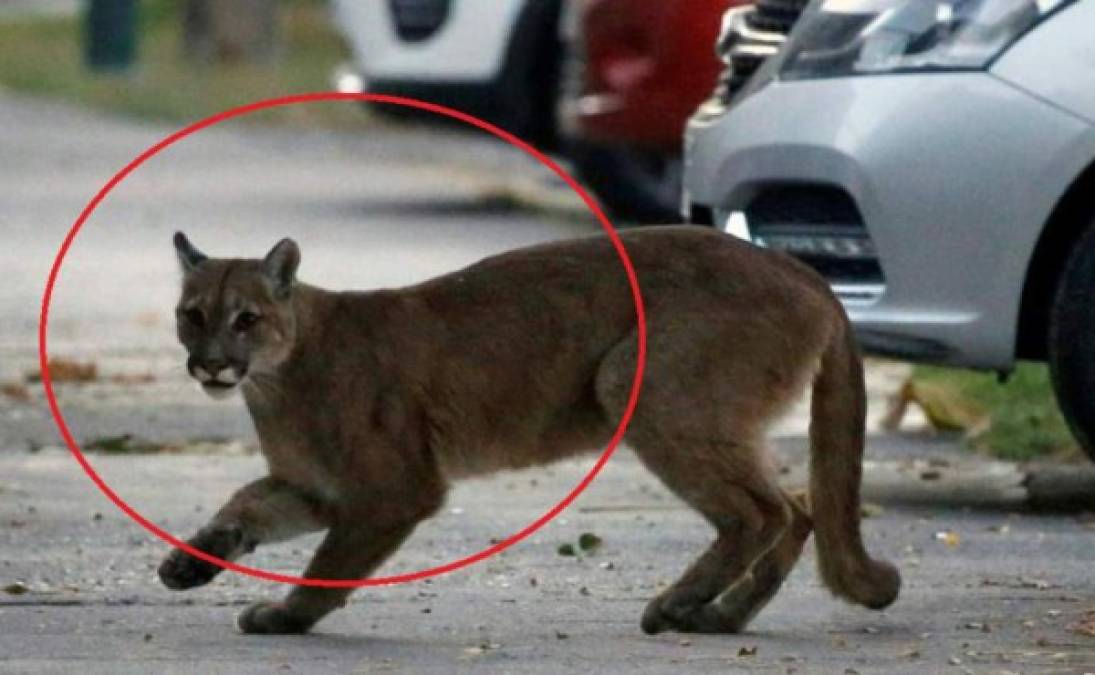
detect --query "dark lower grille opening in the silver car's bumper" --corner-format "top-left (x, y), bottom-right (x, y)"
top-left (745, 185), bottom-right (884, 285)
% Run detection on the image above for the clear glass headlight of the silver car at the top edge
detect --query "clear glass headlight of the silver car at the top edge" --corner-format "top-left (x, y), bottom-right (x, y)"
top-left (780, 0), bottom-right (1072, 79)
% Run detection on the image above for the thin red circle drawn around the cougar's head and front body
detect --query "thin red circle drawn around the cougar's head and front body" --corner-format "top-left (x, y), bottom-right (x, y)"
top-left (38, 92), bottom-right (646, 588)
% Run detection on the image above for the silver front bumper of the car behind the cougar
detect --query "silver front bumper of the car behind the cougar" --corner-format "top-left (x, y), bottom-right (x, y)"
top-left (684, 72), bottom-right (1087, 369)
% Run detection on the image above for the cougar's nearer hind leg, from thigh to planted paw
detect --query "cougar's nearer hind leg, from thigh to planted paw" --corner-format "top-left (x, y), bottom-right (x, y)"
top-left (597, 324), bottom-right (793, 633)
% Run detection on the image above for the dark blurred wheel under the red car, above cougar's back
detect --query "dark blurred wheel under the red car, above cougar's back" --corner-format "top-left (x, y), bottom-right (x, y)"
top-left (567, 140), bottom-right (683, 224)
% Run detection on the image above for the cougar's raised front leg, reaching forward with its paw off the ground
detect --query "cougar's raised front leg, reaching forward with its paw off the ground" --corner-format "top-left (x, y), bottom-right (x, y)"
top-left (159, 477), bottom-right (331, 591)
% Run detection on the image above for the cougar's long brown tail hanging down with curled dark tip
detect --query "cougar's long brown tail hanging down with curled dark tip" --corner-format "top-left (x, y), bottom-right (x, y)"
top-left (810, 320), bottom-right (901, 609)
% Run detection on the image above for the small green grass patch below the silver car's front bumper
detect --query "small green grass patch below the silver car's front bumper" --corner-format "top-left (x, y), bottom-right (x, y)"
top-left (912, 364), bottom-right (1081, 460)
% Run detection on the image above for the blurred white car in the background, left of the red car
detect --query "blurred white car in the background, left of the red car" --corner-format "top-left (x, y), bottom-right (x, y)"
top-left (334, 0), bottom-right (562, 147)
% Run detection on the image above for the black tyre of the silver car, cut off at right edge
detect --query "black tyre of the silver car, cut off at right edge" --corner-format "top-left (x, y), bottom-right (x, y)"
top-left (1049, 222), bottom-right (1095, 460)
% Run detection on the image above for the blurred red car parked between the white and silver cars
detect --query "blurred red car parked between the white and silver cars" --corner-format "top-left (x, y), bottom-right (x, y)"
top-left (560, 0), bottom-right (746, 222)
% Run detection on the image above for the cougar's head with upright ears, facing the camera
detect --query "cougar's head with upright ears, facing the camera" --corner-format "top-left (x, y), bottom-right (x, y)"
top-left (174, 232), bottom-right (300, 398)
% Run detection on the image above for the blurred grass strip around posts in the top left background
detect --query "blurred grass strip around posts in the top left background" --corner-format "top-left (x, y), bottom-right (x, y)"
top-left (0, 0), bottom-right (367, 128)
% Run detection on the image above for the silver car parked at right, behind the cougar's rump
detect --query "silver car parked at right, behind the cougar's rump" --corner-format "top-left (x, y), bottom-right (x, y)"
top-left (683, 0), bottom-right (1095, 457)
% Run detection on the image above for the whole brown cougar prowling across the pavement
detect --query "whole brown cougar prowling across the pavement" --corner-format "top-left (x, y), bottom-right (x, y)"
top-left (159, 226), bottom-right (900, 633)
